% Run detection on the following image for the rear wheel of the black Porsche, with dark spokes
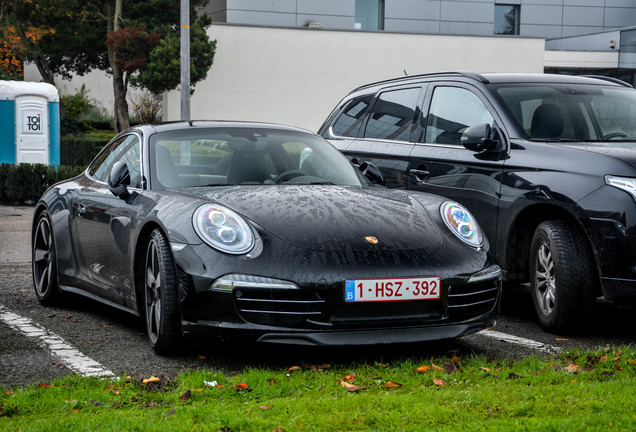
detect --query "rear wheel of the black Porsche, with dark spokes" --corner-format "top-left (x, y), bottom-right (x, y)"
top-left (31, 210), bottom-right (60, 306)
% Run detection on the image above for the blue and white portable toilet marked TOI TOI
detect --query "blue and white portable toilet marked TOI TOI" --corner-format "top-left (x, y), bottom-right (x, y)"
top-left (0, 81), bottom-right (60, 165)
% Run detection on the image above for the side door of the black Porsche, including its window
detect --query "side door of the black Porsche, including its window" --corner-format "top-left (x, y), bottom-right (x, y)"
top-left (73, 134), bottom-right (141, 302)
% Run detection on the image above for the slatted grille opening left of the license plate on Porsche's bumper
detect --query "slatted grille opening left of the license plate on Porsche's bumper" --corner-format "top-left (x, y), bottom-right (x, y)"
top-left (234, 288), bottom-right (325, 326)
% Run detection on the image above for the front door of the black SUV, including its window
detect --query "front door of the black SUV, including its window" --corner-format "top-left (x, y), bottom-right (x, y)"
top-left (408, 83), bottom-right (507, 244)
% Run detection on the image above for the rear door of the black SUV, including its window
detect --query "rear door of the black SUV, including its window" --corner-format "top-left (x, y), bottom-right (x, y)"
top-left (344, 85), bottom-right (422, 188)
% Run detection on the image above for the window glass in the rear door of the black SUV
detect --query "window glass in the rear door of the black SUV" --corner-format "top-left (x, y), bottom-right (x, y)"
top-left (364, 87), bottom-right (420, 141)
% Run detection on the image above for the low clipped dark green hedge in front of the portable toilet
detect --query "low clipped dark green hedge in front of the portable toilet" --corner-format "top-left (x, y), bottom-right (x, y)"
top-left (0, 164), bottom-right (84, 204)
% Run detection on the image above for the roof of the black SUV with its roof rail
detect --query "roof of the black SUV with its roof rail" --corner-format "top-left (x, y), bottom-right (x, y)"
top-left (351, 71), bottom-right (631, 93)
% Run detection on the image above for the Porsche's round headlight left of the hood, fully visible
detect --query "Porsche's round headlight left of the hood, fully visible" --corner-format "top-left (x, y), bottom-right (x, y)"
top-left (192, 204), bottom-right (254, 255)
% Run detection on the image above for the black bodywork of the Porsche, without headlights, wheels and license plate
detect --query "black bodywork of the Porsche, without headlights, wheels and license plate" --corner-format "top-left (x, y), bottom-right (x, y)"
top-left (33, 122), bottom-right (501, 350)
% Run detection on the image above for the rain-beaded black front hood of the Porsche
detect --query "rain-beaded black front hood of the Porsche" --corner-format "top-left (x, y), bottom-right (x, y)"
top-left (184, 185), bottom-right (441, 250)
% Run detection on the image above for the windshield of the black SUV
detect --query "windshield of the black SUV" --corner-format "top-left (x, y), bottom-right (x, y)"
top-left (493, 83), bottom-right (636, 142)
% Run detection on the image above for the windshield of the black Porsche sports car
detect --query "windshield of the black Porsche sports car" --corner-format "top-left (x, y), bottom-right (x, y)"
top-left (150, 127), bottom-right (366, 189)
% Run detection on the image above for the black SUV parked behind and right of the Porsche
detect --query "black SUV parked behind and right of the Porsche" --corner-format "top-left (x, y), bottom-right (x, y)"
top-left (319, 72), bottom-right (636, 332)
